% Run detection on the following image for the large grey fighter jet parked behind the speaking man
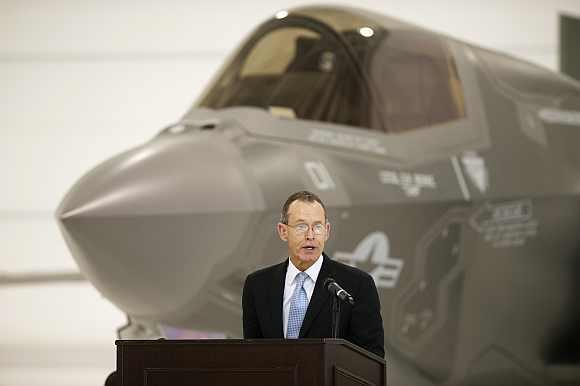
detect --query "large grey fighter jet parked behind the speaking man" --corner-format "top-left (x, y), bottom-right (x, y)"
top-left (57, 6), bottom-right (580, 386)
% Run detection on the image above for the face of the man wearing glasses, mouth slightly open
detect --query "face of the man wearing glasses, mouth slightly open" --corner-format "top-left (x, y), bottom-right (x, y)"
top-left (277, 200), bottom-right (330, 271)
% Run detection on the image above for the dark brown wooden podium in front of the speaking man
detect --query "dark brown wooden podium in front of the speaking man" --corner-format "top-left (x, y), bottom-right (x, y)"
top-left (107, 339), bottom-right (387, 386)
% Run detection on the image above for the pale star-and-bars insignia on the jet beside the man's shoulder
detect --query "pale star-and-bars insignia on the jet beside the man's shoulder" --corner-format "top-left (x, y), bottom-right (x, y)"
top-left (334, 232), bottom-right (404, 288)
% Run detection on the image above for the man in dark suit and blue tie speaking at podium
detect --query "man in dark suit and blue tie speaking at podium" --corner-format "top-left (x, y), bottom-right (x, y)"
top-left (242, 191), bottom-right (385, 357)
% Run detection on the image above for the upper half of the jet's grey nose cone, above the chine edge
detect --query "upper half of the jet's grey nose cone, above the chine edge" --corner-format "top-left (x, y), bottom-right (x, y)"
top-left (57, 138), bottom-right (254, 222)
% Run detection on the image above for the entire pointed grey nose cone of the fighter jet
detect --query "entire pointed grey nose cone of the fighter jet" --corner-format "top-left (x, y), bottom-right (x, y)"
top-left (57, 137), bottom-right (263, 319)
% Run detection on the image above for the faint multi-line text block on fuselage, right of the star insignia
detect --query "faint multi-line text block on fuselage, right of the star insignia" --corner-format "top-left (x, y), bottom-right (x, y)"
top-left (470, 200), bottom-right (538, 248)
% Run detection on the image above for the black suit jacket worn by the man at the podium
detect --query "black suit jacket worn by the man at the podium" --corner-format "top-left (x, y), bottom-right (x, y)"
top-left (242, 254), bottom-right (385, 357)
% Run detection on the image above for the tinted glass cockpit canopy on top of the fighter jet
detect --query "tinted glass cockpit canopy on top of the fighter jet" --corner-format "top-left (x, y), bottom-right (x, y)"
top-left (198, 7), bottom-right (465, 132)
